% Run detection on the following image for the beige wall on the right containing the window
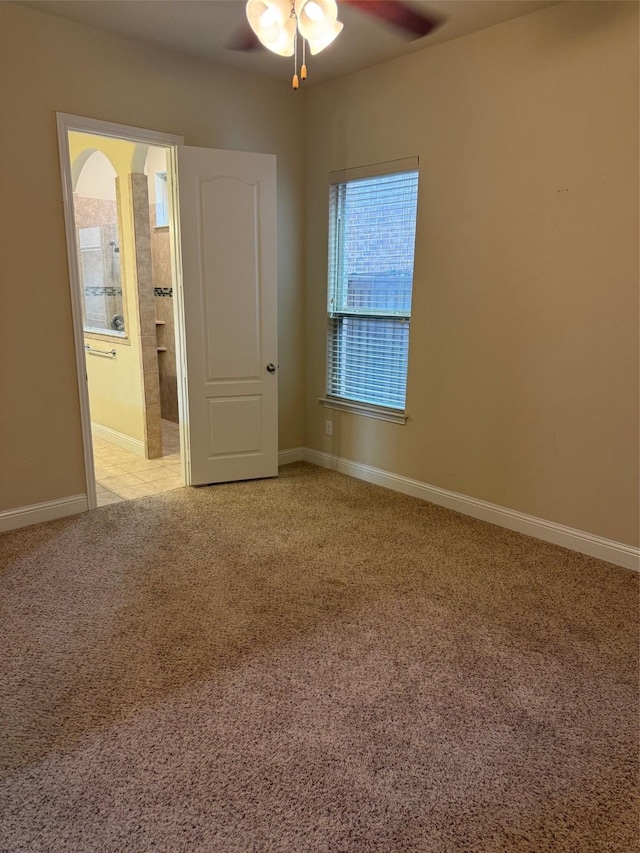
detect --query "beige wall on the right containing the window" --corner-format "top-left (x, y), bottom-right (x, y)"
top-left (305, 2), bottom-right (639, 545)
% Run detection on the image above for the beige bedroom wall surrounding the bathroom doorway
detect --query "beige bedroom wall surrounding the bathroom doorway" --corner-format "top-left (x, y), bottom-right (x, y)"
top-left (0, 3), bottom-right (304, 511)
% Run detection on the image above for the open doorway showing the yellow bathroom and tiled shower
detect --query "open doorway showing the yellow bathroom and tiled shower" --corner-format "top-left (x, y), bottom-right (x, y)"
top-left (62, 122), bottom-right (184, 506)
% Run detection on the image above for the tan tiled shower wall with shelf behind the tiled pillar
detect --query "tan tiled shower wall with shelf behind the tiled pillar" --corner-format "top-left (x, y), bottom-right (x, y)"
top-left (149, 205), bottom-right (178, 423)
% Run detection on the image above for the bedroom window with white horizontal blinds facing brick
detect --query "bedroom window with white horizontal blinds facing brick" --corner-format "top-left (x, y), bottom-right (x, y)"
top-left (324, 160), bottom-right (418, 412)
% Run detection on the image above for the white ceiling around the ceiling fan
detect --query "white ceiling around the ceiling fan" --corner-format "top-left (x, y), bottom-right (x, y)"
top-left (20, 0), bottom-right (558, 85)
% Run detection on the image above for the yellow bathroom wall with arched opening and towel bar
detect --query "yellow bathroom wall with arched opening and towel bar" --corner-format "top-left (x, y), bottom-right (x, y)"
top-left (69, 133), bottom-right (145, 452)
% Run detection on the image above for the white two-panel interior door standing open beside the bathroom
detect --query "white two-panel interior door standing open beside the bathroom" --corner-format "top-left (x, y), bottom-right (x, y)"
top-left (177, 146), bottom-right (278, 485)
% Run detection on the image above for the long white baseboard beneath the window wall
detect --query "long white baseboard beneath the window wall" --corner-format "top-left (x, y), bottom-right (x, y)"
top-left (303, 448), bottom-right (640, 572)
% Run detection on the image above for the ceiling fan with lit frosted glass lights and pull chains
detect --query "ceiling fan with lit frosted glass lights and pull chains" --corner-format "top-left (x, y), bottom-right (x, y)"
top-left (229, 0), bottom-right (443, 89)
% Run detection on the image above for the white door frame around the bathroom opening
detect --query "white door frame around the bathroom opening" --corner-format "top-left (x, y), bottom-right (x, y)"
top-left (56, 113), bottom-right (189, 509)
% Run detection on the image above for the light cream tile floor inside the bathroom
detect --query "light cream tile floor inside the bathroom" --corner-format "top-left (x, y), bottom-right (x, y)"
top-left (93, 420), bottom-right (183, 506)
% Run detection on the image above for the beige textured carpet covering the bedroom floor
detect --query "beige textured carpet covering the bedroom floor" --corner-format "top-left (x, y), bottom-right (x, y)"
top-left (0, 464), bottom-right (639, 853)
